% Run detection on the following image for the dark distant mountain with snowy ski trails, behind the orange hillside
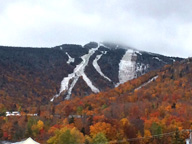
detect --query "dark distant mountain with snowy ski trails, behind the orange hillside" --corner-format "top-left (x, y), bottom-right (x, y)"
top-left (0, 42), bottom-right (182, 106)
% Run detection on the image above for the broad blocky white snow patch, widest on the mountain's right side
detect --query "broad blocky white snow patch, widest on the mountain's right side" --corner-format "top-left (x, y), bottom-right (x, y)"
top-left (116, 49), bottom-right (136, 87)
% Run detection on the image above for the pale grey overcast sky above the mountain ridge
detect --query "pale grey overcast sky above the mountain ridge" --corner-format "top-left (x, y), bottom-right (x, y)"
top-left (0, 0), bottom-right (192, 57)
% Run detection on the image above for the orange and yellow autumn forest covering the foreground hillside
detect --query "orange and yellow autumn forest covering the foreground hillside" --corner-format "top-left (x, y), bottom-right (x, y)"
top-left (0, 58), bottom-right (192, 144)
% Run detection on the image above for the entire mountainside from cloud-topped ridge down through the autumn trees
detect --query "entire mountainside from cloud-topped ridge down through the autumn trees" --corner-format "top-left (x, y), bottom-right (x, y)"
top-left (0, 43), bottom-right (192, 144)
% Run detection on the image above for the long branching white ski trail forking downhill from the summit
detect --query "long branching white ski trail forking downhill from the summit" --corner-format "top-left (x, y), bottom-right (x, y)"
top-left (50, 44), bottom-right (100, 101)
